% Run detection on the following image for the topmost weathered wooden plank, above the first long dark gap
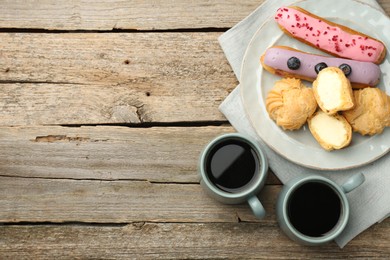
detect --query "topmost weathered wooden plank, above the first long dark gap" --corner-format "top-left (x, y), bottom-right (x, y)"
top-left (0, 0), bottom-right (263, 30)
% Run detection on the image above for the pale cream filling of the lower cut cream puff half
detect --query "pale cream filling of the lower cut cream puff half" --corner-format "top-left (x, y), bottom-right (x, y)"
top-left (311, 113), bottom-right (348, 147)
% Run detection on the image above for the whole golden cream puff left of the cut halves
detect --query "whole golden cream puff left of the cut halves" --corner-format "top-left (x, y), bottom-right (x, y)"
top-left (265, 78), bottom-right (317, 130)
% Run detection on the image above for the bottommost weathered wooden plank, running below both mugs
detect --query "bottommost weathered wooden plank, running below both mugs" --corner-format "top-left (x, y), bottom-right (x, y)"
top-left (0, 219), bottom-right (390, 259)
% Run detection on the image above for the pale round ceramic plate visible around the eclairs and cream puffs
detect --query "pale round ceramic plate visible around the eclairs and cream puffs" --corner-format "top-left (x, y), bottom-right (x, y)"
top-left (240, 0), bottom-right (390, 170)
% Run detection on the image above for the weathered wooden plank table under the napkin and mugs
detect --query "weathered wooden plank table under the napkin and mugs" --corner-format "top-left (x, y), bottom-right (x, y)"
top-left (0, 0), bottom-right (390, 259)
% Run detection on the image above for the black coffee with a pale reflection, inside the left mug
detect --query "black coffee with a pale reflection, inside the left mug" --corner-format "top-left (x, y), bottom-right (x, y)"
top-left (206, 139), bottom-right (260, 193)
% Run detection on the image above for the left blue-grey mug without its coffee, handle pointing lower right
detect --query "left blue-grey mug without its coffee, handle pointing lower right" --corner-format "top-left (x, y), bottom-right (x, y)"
top-left (198, 133), bottom-right (268, 219)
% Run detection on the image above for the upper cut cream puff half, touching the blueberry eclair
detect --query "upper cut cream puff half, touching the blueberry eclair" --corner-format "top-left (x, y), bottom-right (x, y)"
top-left (313, 67), bottom-right (354, 115)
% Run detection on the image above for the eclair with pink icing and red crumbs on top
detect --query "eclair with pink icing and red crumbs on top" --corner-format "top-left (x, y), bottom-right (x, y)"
top-left (275, 6), bottom-right (386, 64)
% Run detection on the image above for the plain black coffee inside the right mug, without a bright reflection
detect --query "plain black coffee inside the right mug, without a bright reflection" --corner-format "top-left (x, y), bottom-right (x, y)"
top-left (288, 182), bottom-right (341, 237)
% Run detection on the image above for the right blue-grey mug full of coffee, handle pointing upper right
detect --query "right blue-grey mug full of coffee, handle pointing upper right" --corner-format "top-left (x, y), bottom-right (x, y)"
top-left (276, 173), bottom-right (365, 245)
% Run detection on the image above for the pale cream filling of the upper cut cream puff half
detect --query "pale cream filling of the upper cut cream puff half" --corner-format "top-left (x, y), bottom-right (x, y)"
top-left (317, 72), bottom-right (342, 110)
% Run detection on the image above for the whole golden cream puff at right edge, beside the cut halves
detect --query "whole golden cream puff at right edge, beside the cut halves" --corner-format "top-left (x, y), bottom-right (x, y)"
top-left (342, 88), bottom-right (390, 135)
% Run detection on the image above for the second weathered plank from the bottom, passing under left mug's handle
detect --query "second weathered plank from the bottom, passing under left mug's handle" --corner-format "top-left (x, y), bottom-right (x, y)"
top-left (0, 177), bottom-right (280, 223)
